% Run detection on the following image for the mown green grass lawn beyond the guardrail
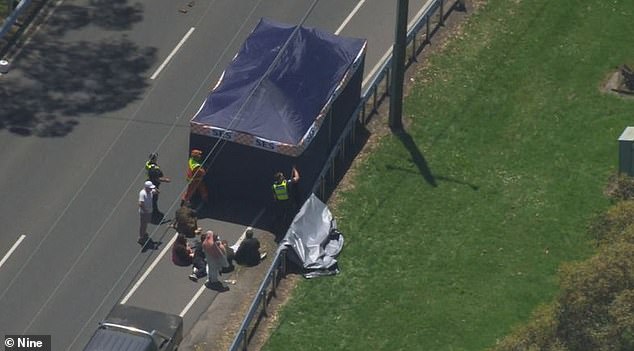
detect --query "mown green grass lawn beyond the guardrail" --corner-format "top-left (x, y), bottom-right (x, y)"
top-left (265, 0), bottom-right (634, 350)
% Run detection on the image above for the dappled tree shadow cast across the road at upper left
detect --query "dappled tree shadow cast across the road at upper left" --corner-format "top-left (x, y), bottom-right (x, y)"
top-left (0, 0), bottom-right (156, 137)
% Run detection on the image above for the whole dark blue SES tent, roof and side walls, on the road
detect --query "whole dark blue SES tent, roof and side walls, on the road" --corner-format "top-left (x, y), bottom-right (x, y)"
top-left (189, 19), bottom-right (366, 225)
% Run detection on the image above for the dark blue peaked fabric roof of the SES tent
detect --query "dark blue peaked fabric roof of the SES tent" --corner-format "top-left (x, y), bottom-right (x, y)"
top-left (191, 19), bottom-right (366, 156)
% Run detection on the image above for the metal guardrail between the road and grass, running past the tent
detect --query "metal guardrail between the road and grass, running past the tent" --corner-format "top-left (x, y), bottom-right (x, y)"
top-left (229, 0), bottom-right (464, 351)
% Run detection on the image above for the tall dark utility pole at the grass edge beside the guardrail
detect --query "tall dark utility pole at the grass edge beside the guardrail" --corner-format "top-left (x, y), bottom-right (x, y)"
top-left (390, 0), bottom-right (409, 131)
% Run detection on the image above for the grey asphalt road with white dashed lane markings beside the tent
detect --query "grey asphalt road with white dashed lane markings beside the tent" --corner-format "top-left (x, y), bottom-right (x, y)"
top-left (0, 0), bottom-right (424, 350)
